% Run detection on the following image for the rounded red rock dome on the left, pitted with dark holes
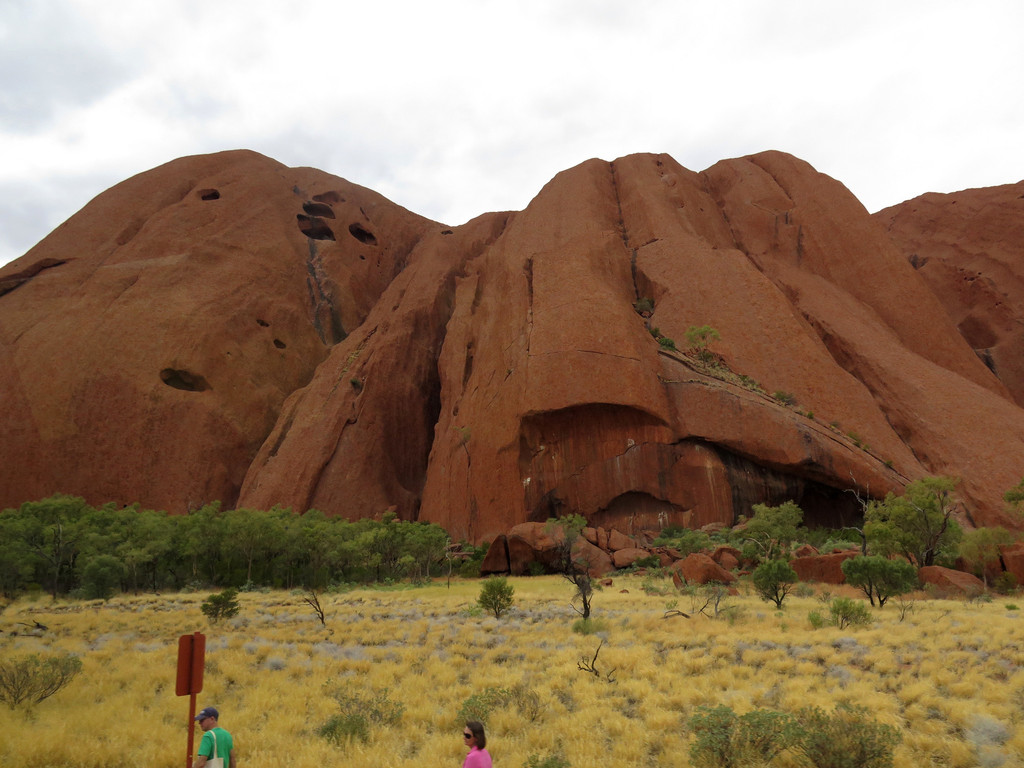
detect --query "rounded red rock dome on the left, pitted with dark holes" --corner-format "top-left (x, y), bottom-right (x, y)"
top-left (0, 152), bottom-right (440, 512)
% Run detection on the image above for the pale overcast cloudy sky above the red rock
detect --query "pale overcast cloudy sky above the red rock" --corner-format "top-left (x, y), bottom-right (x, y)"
top-left (0, 0), bottom-right (1024, 264)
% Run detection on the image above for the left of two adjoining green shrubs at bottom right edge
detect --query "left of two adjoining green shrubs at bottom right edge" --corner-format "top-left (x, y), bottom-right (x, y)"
top-left (688, 705), bottom-right (800, 768)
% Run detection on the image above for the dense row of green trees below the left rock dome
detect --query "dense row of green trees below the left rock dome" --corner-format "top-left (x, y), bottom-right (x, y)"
top-left (0, 495), bottom-right (451, 598)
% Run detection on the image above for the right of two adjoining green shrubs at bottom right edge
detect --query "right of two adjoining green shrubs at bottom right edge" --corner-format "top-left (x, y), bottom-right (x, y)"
top-left (796, 703), bottom-right (900, 768)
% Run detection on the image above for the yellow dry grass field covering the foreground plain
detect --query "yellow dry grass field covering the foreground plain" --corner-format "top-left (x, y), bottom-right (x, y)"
top-left (0, 575), bottom-right (1024, 768)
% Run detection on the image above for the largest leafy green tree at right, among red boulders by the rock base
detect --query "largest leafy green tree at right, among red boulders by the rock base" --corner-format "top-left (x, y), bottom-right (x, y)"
top-left (864, 477), bottom-right (963, 566)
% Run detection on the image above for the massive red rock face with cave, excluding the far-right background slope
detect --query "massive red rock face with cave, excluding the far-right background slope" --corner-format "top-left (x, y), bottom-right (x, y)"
top-left (0, 152), bottom-right (1024, 542)
